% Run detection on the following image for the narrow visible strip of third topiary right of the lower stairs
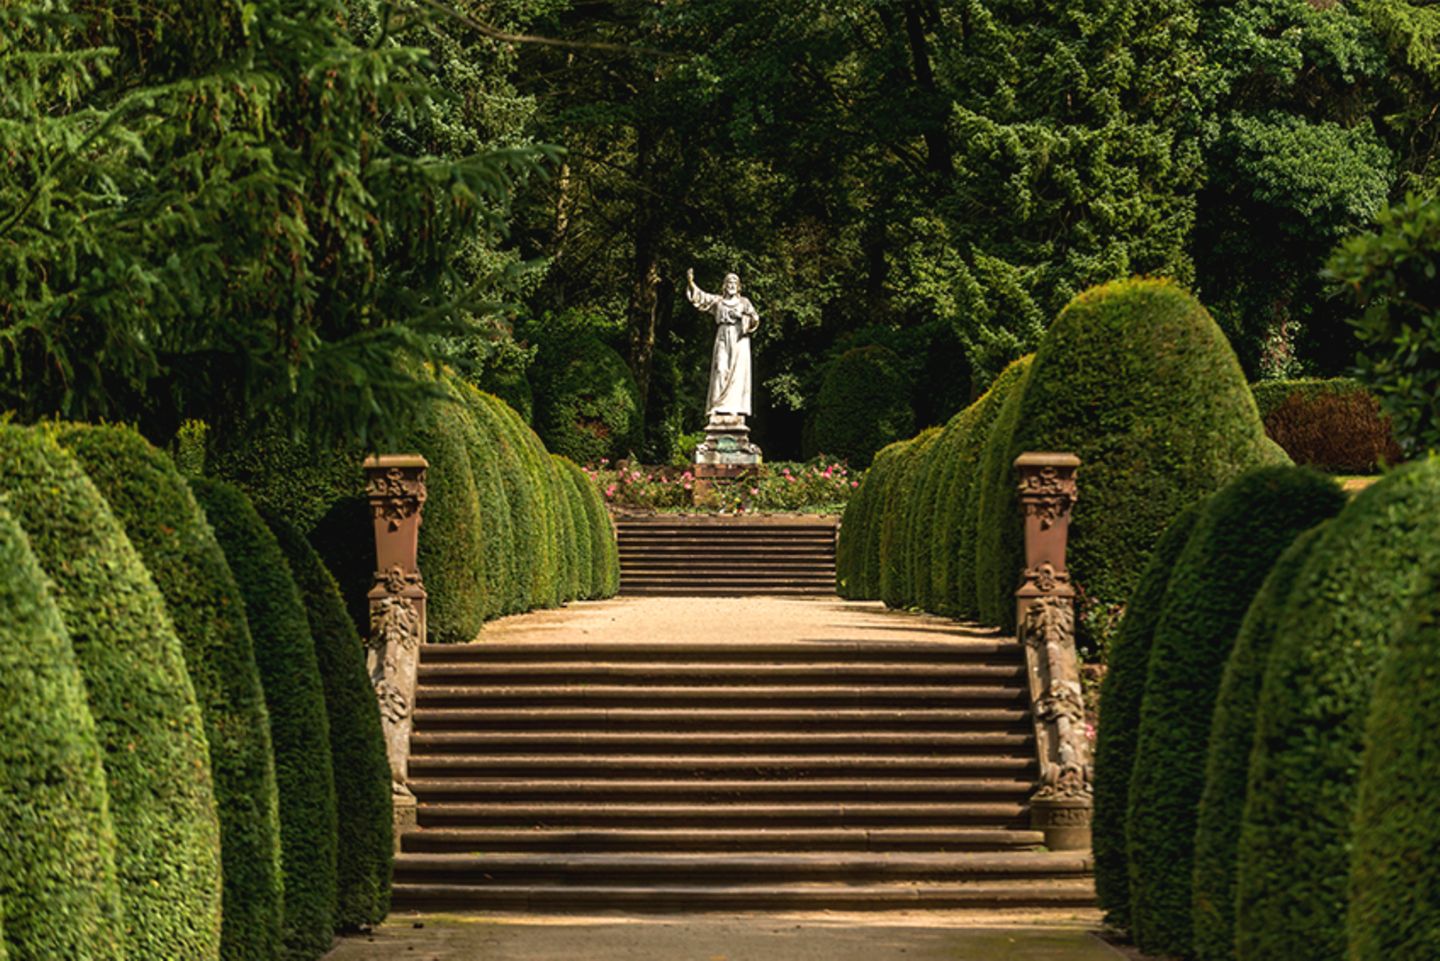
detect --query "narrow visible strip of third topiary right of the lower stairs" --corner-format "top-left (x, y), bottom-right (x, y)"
top-left (1191, 523), bottom-right (1325, 961)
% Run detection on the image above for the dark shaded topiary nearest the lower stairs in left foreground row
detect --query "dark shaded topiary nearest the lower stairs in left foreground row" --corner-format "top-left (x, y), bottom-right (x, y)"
top-left (262, 513), bottom-right (395, 931)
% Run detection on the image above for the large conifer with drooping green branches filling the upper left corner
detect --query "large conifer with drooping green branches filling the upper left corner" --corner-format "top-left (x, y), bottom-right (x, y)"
top-left (0, 0), bottom-right (539, 444)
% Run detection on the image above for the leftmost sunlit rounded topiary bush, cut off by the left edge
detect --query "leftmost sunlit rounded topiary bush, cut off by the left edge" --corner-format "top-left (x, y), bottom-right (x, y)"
top-left (0, 500), bottom-right (125, 961)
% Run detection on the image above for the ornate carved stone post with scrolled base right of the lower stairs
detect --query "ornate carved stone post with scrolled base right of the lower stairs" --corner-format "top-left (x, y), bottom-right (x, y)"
top-left (1015, 452), bottom-right (1093, 850)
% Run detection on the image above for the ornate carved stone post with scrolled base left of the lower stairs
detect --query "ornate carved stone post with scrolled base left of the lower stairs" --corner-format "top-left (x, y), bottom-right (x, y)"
top-left (364, 454), bottom-right (429, 844)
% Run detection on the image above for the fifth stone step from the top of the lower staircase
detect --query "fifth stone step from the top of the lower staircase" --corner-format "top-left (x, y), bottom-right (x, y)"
top-left (410, 730), bottom-right (1034, 756)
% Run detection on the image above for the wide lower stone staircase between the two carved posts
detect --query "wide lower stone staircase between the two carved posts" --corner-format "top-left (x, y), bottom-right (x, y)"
top-left (395, 639), bottom-right (1094, 911)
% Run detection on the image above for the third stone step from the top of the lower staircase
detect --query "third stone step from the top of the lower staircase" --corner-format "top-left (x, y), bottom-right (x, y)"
top-left (416, 683), bottom-right (1028, 709)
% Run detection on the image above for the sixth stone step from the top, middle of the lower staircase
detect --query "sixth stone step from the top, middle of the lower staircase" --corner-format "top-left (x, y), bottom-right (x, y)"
top-left (409, 754), bottom-right (1035, 778)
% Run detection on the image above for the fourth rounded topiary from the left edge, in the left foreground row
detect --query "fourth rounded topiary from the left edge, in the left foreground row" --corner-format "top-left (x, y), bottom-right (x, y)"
top-left (190, 478), bottom-right (337, 958)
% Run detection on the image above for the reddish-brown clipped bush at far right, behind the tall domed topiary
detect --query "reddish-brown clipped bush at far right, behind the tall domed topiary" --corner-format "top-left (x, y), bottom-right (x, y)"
top-left (1251, 377), bottom-right (1404, 474)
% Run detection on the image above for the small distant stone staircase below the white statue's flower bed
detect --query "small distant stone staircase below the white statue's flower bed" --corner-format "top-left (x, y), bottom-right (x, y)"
top-left (616, 516), bottom-right (835, 596)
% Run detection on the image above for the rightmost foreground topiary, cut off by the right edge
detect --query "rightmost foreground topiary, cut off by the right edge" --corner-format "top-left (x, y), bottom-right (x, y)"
top-left (1346, 568), bottom-right (1440, 961)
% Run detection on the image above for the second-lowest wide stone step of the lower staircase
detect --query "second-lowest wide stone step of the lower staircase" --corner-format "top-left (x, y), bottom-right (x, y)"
top-left (395, 852), bottom-right (1092, 886)
